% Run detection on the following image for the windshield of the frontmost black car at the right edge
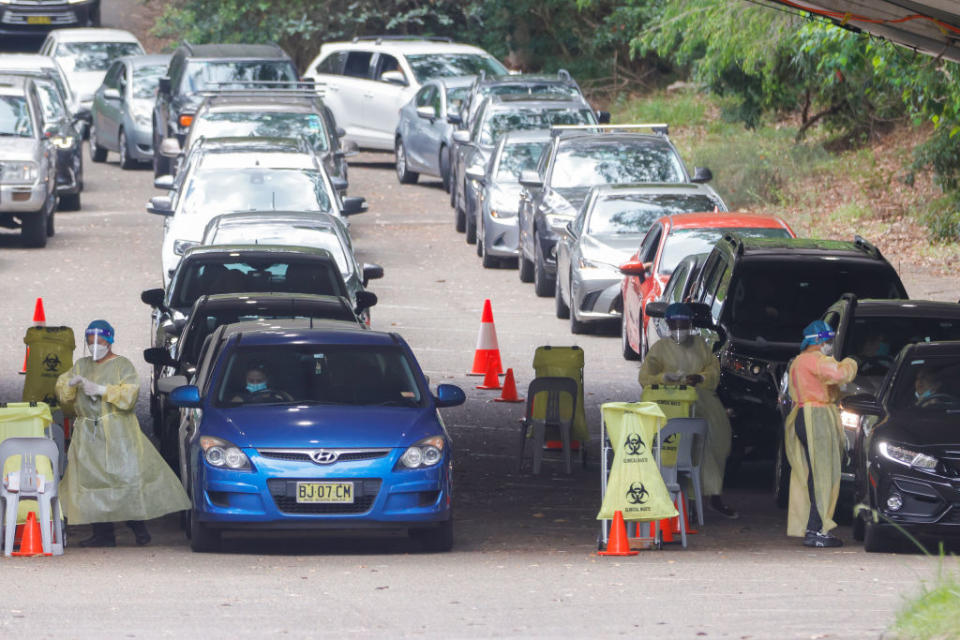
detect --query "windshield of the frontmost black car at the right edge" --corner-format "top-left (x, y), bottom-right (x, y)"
top-left (890, 356), bottom-right (960, 416)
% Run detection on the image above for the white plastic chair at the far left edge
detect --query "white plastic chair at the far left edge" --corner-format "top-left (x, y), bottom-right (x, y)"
top-left (0, 438), bottom-right (63, 556)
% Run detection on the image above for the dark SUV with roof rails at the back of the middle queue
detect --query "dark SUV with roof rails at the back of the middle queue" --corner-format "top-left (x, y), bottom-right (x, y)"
top-left (153, 42), bottom-right (298, 176)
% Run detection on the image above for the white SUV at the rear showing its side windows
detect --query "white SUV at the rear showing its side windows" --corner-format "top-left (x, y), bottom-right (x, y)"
top-left (304, 36), bottom-right (508, 151)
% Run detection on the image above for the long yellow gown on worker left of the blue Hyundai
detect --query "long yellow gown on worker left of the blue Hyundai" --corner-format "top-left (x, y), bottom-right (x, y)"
top-left (56, 356), bottom-right (190, 524)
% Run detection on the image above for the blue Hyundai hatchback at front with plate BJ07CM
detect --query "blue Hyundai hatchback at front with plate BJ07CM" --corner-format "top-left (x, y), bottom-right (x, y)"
top-left (170, 320), bottom-right (465, 551)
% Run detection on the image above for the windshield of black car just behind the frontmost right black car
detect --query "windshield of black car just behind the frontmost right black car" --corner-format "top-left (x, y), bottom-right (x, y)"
top-left (842, 315), bottom-right (960, 376)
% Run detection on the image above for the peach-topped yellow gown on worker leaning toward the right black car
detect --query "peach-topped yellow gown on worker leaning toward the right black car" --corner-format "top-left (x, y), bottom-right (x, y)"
top-left (784, 351), bottom-right (857, 537)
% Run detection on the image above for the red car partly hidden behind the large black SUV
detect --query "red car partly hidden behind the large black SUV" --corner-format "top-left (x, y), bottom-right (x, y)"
top-left (620, 212), bottom-right (796, 360)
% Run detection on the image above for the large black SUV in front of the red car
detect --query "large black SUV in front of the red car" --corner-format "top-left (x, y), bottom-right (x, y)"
top-left (691, 234), bottom-right (907, 469)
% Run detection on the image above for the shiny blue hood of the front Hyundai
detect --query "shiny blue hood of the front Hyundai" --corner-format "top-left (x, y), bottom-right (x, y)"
top-left (212, 405), bottom-right (441, 449)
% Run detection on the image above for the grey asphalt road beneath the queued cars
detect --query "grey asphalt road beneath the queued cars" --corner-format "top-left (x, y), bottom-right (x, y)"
top-left (0, 20), bottom-right (960, 638)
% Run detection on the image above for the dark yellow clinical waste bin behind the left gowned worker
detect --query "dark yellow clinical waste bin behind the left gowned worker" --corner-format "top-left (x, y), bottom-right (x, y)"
top-left (23, 327), bottom-right (76, 413)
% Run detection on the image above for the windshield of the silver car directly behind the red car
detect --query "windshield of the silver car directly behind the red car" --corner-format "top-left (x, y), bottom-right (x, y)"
top-left (587, 193), bottom-right (719, 238)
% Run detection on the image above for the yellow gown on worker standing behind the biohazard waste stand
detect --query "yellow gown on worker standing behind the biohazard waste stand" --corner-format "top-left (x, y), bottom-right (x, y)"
top-left (638, 336), bottom-right (733, 496)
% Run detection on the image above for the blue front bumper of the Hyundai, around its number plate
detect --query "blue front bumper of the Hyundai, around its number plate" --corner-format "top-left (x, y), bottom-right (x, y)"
top-left (193, 449), bottom-right (451, 529)
